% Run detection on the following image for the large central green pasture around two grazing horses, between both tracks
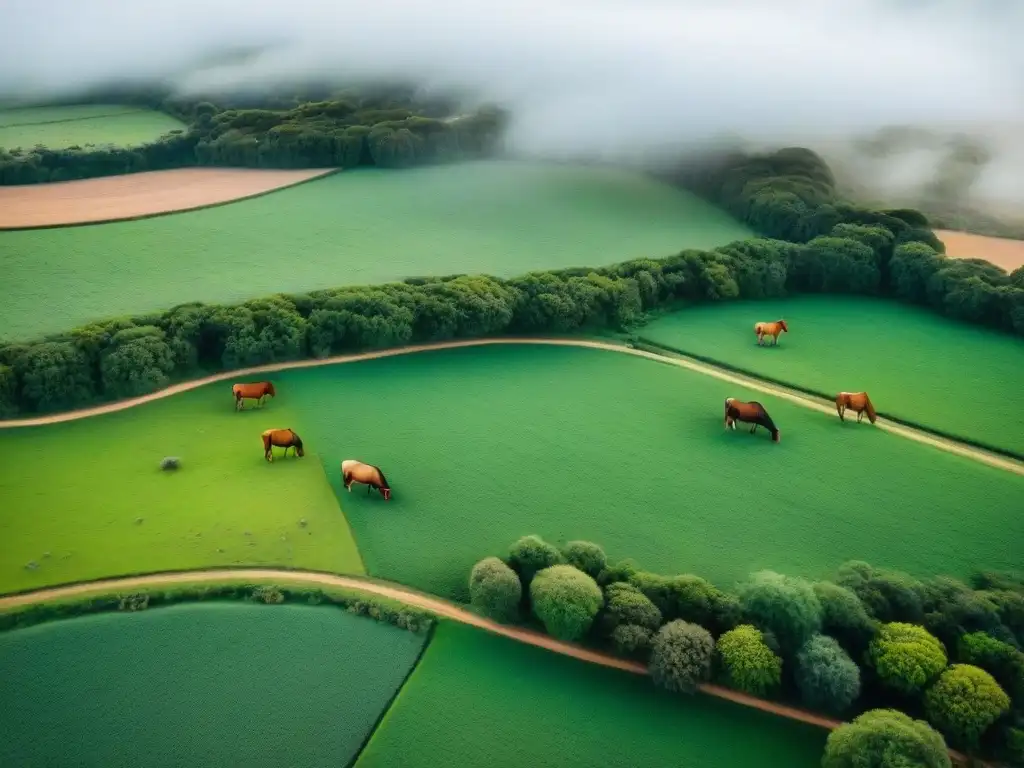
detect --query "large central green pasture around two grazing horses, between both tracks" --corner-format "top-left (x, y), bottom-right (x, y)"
top-left (278, 345), bottom-right (1024, 599)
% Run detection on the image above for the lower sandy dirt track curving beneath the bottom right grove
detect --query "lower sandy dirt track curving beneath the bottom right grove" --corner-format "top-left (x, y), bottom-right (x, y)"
top-left (0, 567), bottom-right (983, 762)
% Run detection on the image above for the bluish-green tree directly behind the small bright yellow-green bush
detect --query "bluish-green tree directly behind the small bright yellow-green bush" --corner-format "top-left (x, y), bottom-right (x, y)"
top-left (739, 570), bottom-right (821, 653)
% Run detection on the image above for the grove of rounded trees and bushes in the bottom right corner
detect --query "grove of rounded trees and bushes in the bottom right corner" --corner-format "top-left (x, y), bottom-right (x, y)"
top-left (469, 536), bottom-right (1024, 766)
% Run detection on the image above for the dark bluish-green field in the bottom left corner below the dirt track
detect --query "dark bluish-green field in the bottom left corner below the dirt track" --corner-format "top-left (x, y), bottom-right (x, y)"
top-left (0, 604), bottom-right (425, 768)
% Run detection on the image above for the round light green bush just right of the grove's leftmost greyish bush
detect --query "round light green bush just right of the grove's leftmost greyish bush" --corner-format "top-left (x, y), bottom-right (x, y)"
top-left (529, 565), bottom-right (604, 640)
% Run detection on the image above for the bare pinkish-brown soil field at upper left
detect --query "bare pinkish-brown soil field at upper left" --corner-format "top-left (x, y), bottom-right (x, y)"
top-left (0, 168), bottom-right (332, 229)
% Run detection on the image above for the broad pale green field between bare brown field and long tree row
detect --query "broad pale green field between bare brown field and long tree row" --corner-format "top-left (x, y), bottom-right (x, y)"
top-left (0, 162), bottom-right (750, 339)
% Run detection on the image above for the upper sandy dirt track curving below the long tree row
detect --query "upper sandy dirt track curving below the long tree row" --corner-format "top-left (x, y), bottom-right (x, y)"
top-left (0, 337), bottom-right (1024, 475)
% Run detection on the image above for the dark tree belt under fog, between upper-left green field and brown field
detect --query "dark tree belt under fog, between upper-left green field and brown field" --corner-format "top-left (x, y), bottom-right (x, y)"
top-left (0, 85), bottom-right (507, 184)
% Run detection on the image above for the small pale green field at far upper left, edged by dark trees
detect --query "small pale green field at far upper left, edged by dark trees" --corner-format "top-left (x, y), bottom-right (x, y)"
top-left (0, 104), bottom-right (184, 150)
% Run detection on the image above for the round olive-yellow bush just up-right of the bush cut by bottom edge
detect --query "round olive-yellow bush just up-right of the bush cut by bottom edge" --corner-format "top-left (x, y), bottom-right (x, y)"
top-left (925, 664), bottom-right (1010, 748)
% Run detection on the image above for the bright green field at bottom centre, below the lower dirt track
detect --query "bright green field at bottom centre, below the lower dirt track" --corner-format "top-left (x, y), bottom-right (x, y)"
top-left (355, 623), bottom-right (825, 768)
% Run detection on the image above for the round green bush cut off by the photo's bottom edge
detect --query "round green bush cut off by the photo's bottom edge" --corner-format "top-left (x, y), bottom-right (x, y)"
top-left (821, 710), bottom-right (952, 768)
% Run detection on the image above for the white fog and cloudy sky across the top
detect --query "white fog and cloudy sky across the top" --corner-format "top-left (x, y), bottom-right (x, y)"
top-left (0, 0), bottom-right (1024, 201)
